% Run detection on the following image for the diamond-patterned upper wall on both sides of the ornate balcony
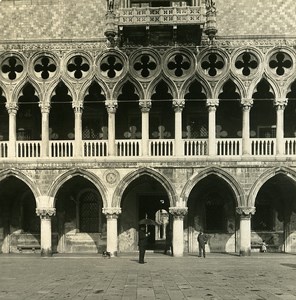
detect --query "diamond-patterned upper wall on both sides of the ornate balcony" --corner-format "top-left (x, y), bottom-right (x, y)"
top-left (0, 0), bottom-right (296, 41)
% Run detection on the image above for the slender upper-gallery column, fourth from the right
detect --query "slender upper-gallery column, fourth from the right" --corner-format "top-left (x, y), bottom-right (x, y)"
top-left (173, 99), bottom-right (185, 156)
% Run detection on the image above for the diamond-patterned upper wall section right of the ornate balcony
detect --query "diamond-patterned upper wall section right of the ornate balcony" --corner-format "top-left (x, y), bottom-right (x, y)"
top-left (215, 0), bottom-right (296, 36)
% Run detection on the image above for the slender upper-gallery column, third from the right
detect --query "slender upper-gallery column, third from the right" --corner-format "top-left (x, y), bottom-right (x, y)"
top-left (207, 99), bottom-right (219, 156)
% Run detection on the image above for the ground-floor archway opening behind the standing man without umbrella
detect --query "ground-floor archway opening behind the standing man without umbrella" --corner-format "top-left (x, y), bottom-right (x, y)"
top-left (185, 174), bottom-right (238, 252)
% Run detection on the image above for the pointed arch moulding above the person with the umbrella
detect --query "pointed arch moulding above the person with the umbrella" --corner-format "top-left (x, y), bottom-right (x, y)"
top-left (112, 167), bottom-right (178, 207)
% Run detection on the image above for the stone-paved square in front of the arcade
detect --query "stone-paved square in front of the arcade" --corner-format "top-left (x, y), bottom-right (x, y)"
top-left (0, 253), bottom-right (296, 300)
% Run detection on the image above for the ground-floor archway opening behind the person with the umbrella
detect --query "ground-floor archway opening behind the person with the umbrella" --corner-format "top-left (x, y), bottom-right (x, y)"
top-left (119, 175), bottom-right (171, 252)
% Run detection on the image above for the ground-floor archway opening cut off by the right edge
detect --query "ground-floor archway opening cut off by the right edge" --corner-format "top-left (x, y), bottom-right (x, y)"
top-left (251, 174), bottom-right (296, 252)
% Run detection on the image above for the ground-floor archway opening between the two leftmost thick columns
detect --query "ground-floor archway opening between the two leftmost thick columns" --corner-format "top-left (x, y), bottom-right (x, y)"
top-left (52, 175), bottom-right (107, 253)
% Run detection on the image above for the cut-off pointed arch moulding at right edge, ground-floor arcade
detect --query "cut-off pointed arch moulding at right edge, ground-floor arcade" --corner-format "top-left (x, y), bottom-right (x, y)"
top-left (247, 167), bottom-right (296, 206)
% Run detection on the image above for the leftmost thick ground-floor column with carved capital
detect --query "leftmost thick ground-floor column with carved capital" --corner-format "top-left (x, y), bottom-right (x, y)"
top-left (36, 207), bottom-right (56, 256)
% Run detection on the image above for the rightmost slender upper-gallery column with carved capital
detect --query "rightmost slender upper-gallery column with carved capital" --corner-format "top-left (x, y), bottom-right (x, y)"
top-left (274, 99), bottom-right (288, 155)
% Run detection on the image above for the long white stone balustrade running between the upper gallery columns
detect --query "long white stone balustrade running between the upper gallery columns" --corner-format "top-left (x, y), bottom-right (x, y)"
top-left (0, 138), bottom-right (296, 159)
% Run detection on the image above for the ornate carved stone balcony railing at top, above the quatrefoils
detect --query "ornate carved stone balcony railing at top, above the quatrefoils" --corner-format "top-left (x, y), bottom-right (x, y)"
top-left (118, 6), bottom-right (205, 25)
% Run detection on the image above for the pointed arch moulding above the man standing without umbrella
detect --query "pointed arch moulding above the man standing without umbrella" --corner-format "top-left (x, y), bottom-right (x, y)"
top-left (180, 166), bottom-right (245, 206)
